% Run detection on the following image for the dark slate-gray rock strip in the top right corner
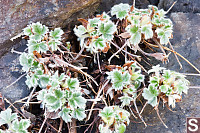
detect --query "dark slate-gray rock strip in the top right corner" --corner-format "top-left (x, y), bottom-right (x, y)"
top-left (158, 0), bottom-right (200, 13)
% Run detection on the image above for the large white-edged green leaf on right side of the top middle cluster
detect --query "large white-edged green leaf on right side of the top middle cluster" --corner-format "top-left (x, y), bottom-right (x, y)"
top-left (98, 21), bottom-right (117, 41)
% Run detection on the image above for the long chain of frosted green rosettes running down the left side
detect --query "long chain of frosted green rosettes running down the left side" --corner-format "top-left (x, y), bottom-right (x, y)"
top-left (20, 22), bottom-right (86, 122)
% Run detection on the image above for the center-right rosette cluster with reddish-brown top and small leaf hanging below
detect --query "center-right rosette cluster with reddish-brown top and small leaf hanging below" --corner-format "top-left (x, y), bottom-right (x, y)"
top-left (107, 62), bottom-right (144, 106)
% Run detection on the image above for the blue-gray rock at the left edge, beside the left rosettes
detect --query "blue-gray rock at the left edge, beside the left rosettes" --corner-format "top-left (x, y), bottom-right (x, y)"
top-left (0, 40), bottom-right (30, 107)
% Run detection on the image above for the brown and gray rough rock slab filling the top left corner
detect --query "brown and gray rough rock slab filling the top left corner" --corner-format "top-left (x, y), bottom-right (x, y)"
top-left (0, 0), bottom-right (100, 56)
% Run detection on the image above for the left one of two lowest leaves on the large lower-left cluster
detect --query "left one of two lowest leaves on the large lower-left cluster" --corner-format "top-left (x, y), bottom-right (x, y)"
top-left (58, 108), bottom-right (72, 123)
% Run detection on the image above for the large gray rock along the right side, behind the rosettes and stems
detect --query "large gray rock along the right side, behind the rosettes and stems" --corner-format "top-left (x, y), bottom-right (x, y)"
top-left (126, 13), bottom-right (200, 133)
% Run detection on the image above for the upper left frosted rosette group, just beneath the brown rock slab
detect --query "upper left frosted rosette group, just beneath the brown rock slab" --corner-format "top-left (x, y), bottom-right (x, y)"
top-left (24, 22), bottom-right (64, 53)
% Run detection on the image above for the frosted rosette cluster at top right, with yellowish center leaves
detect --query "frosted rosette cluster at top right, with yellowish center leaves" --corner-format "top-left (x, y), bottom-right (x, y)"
top-left (111, 3), bottom-right (173, 47)
